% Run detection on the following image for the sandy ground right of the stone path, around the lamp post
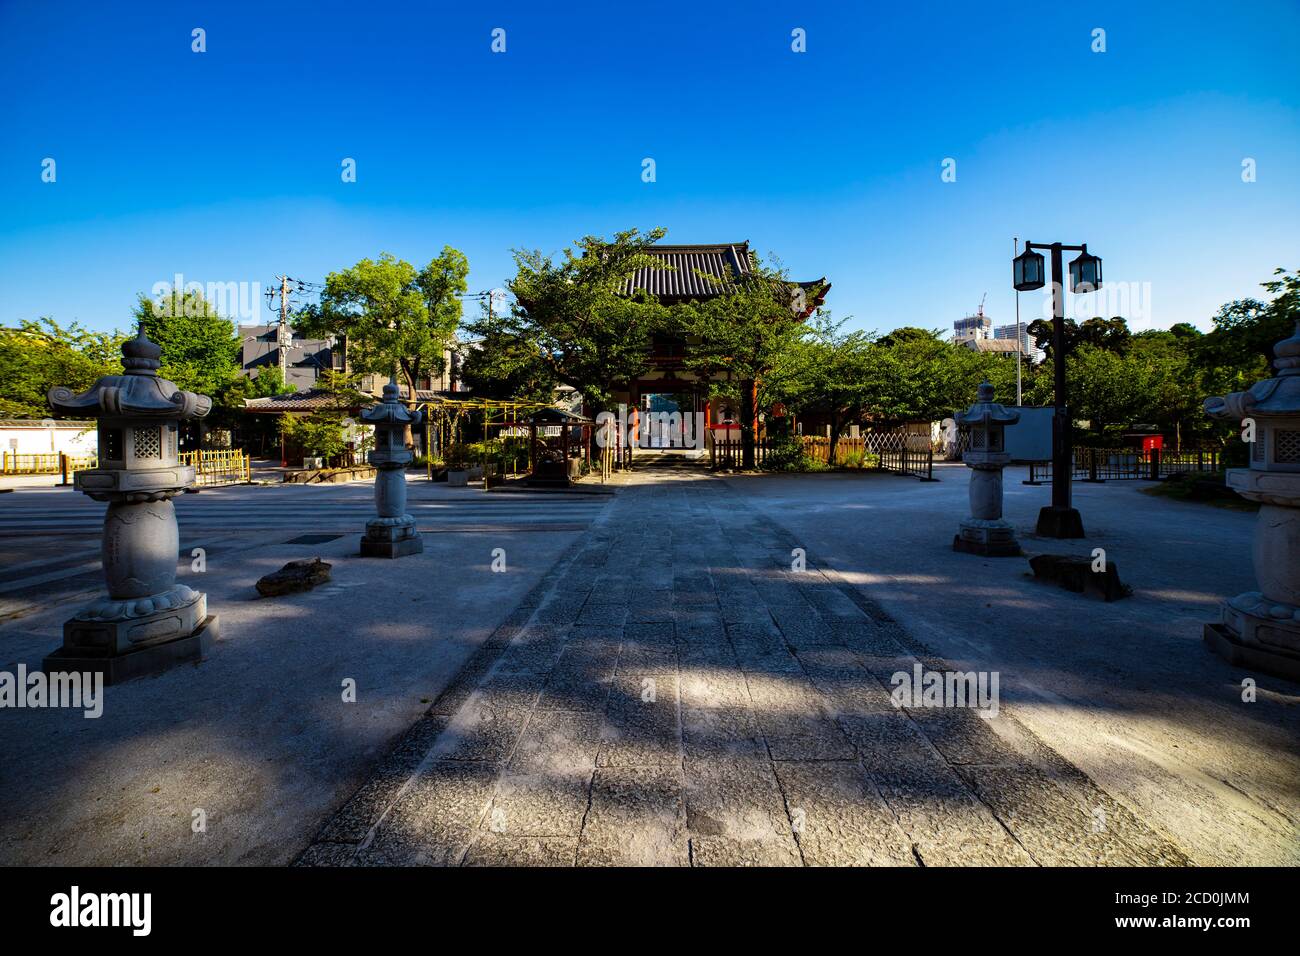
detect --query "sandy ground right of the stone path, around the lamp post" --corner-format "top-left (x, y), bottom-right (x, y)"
top-left (728, 466), bottom-right (1300, 865)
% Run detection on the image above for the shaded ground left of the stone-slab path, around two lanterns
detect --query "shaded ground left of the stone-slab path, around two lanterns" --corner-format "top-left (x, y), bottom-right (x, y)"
top-left (0, 481), bottom-right (607, 865)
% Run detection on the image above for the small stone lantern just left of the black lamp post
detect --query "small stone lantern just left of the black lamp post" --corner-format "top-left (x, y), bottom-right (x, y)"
top-left (953, 381), bottom-right (1021, 558)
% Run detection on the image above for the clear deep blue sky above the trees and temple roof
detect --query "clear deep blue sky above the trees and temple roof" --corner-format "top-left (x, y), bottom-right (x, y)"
top-left (0, 0), bottom-right (1300, 340)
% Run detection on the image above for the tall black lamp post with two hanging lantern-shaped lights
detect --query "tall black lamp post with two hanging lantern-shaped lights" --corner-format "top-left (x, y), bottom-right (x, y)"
top-left (1011, 242), bottom-right (1101, 537)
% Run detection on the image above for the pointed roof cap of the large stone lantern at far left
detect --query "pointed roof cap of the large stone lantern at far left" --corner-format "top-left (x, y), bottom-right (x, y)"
top-left (48, 324), bottom-right (212, 419)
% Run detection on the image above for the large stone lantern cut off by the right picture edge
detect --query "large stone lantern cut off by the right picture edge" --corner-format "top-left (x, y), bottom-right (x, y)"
top-left (1204, 323), bottom-right (1300, 680)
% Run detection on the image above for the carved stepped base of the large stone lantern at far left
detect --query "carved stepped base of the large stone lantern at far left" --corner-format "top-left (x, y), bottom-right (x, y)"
top-left (42, 584), bottom-right (218, 684)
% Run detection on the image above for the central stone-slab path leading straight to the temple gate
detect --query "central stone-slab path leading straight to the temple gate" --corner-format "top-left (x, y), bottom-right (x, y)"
top-left (300, 471), bottom-right (1187, 866)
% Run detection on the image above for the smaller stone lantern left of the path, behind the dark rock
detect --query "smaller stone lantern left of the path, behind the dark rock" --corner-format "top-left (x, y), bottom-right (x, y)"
top-left (361, 382), bottom-right (424, 558)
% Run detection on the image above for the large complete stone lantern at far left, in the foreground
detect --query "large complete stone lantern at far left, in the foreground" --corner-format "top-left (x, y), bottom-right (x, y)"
top-left (44, 325), bottom-right (217, 684)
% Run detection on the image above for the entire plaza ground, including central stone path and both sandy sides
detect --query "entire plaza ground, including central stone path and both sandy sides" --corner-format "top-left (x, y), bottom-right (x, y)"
top-left (0, 466), bottom-right (1300, 866)
